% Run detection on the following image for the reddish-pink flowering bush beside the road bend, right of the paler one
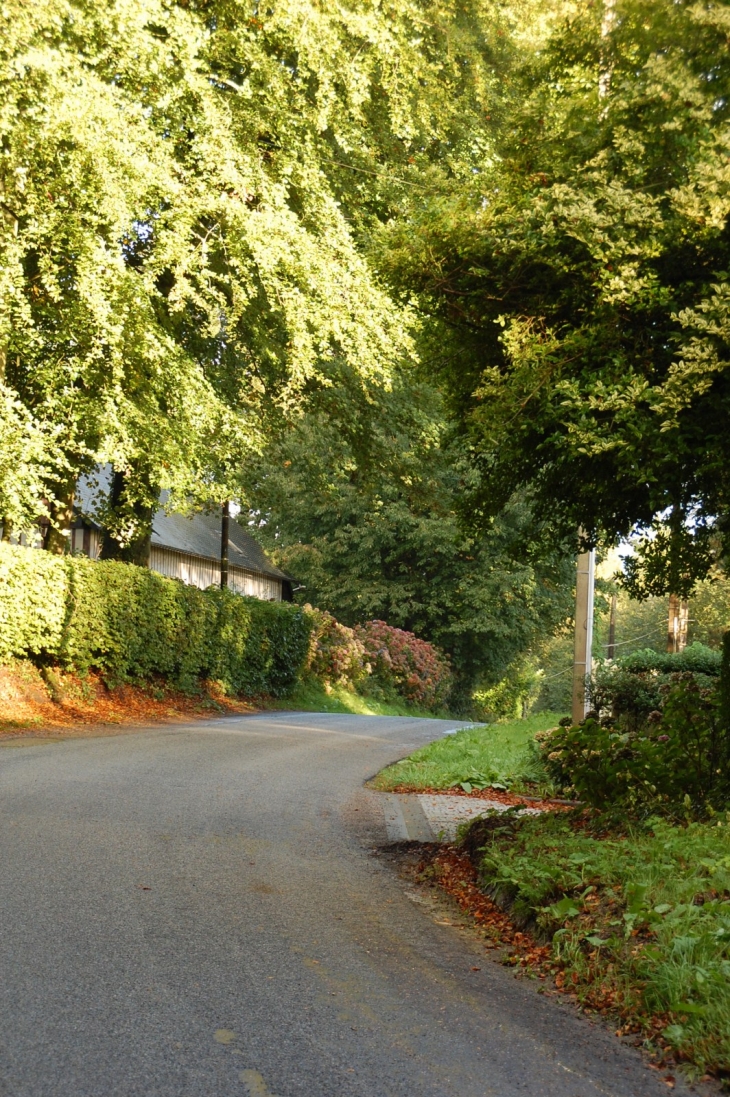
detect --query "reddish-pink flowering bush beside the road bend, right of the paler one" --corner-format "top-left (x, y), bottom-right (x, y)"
top-left (355, 621), bottom-right (452, 709)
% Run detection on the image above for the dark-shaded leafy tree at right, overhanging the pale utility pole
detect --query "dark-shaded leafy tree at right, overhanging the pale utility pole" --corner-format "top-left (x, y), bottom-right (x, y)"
top-left (379, 0), bottom-right (730, 592)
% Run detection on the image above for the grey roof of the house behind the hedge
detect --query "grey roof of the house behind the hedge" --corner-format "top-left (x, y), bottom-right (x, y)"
top-left (76, 465), bottom-right (290, 579)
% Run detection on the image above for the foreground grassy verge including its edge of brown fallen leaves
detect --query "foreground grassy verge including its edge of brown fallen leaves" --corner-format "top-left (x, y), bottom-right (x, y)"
top-left (412, 810), bottom-right (730, 1085)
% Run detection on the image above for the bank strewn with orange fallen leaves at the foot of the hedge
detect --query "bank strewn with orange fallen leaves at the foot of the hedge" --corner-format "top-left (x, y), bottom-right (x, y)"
top-left (0, 660), bottom-right (257, 738)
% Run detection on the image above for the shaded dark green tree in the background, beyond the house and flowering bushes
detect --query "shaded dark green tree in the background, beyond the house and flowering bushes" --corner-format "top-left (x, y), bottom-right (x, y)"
top-left (246, 373), bottom-right (571, 705)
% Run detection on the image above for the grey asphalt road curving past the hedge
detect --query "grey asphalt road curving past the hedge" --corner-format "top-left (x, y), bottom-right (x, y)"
top-left (0, 713), bottom-right (686, 1097)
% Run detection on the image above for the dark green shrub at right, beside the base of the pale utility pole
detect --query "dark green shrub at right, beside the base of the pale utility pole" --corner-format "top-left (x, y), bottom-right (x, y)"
top-left (537, 644), bottom-right (730, 815)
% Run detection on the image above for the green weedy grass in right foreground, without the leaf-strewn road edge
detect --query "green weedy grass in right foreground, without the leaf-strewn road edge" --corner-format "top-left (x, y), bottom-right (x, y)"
top-left (471, 813), bottom-right (730, 1074)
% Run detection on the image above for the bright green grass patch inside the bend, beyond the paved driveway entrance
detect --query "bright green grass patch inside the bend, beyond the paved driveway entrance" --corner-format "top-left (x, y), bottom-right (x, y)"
top-left (372, 712), bottom-right (561, 791)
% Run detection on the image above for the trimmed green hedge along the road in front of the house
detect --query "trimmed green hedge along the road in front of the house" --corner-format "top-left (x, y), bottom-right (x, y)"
top-left (0, 543), bottom-right (312, 697)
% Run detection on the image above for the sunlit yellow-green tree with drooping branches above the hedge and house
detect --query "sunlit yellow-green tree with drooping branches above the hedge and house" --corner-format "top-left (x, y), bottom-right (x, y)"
top-left (5, 0), bottom-right (491, 547)
